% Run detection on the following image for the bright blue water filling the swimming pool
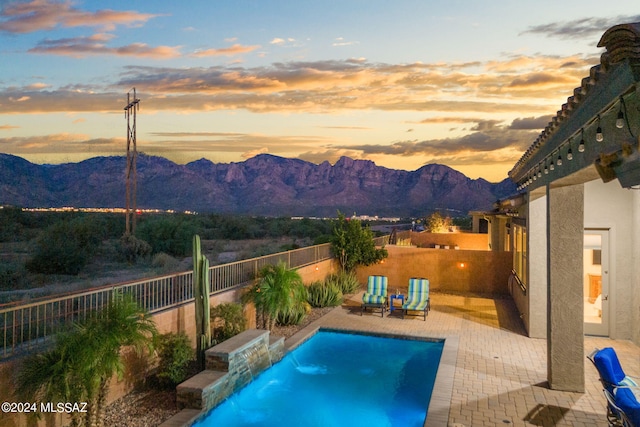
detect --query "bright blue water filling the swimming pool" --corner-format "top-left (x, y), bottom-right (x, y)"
top-left (194, 331), bottom-right (444, 427)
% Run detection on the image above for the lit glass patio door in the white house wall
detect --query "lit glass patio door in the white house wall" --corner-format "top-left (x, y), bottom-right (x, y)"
top-left (583, 229), bottom-right (610, 336)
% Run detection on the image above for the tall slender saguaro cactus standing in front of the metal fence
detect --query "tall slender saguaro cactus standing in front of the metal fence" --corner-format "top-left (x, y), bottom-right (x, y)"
top-left (193, 234), bottom-right (211, 369)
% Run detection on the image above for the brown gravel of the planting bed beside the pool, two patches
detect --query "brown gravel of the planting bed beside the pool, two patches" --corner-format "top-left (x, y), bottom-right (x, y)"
top-left (104, 307), bottom-right (334, 427)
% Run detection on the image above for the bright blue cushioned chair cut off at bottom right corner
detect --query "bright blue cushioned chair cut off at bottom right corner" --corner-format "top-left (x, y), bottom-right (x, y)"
top-left (587, 347), bottom-right (640, 427)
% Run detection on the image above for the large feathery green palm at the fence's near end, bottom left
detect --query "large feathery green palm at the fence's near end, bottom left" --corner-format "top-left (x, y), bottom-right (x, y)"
top-left (16, 292), bottom-right (156, 426)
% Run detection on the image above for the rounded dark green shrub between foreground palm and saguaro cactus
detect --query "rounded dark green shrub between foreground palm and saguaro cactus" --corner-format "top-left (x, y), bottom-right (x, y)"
top-left (156, 332), bottom-right (194, 388)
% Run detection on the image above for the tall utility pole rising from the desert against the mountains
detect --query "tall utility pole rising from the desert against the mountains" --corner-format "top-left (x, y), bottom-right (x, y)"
top-left (124, 87), bottom-right (140, 235)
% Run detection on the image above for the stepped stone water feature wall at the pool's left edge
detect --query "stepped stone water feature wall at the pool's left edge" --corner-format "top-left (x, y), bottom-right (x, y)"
top-left (177, 329), bottom-right (284, 422)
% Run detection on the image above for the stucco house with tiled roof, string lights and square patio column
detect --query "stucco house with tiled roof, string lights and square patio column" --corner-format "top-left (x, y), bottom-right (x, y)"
top-left (508, 23), bottom-right (640, 391)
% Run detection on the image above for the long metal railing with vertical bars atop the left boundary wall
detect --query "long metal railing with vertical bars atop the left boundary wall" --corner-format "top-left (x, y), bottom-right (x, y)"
top-left (0, 243), bottom-right (331, 360)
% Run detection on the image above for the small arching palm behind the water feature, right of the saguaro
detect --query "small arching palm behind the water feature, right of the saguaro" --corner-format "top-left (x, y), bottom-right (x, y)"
top-left (245, 262), bottom-right (308, 330)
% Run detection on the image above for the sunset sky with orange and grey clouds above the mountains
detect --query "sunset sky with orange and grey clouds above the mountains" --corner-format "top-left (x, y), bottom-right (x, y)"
top-left (0, 0), bottom-right (640, 182)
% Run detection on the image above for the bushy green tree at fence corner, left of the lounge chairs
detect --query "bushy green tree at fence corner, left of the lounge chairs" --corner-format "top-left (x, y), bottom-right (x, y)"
top-left (331, 212), bottom-right (388, 272)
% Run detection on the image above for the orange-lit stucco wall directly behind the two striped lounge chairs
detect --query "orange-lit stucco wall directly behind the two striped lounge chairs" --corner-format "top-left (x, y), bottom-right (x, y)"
top-left (357, 246), bottom-right (512, 294)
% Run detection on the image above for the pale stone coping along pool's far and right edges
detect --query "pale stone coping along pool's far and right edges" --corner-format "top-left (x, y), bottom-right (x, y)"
top-left (285, 326), bottom-right (460, 427)
